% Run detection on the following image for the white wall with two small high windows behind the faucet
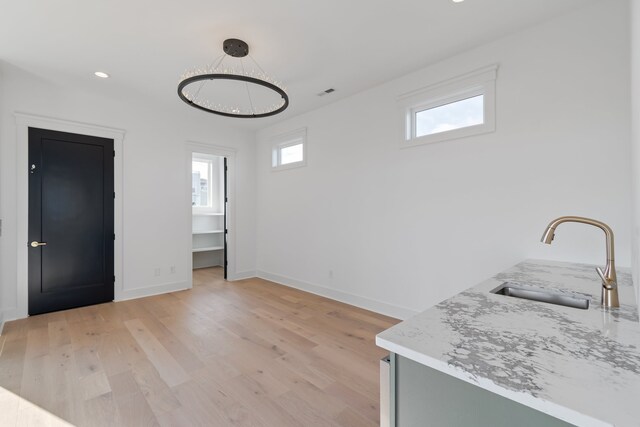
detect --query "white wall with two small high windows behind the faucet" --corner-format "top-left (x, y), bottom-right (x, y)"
top-left (256, 2), bottom-right (631, 317)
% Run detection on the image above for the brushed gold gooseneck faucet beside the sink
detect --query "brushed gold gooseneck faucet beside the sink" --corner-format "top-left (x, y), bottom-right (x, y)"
top-left (541, 216), bottom-right (620, 307)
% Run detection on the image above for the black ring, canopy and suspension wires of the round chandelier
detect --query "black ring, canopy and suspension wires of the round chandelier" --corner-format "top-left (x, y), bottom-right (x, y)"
top-left (178, 39), bottom-right (289, 119)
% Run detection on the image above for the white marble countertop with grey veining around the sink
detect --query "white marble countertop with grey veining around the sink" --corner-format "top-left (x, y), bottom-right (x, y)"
top-left (376, 260), bottom-right (640, 426)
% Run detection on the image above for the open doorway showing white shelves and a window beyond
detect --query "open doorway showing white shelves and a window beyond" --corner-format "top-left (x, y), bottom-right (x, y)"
top-left (191, 152), bottom-right (229, 280)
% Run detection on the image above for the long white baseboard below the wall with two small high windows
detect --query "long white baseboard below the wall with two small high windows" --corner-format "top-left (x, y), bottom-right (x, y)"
top-left (256, 270), bottom-right (419, 320)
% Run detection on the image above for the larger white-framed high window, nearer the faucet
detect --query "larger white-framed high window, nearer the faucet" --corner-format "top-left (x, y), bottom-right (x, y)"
top-left (398, 65), bottom-right (498, 147)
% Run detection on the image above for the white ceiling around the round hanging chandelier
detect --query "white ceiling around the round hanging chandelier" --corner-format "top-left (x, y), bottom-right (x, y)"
top-left (0, 0), bottom-right (588, 129)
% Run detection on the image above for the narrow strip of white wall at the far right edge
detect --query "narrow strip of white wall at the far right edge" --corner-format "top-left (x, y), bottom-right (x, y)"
top-left (630, 0), bottom-right (640, 306)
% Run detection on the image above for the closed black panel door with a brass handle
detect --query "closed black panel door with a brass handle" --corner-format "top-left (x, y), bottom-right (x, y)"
top-left (25, 128), bottom-right (114, 315)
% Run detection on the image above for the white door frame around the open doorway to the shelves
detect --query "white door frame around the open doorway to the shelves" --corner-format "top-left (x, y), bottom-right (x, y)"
top-left (185, 141), bottom-right (237, 288)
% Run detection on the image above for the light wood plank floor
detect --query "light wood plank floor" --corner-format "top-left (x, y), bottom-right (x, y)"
top-left (0, 268), bottom-right (398, 427)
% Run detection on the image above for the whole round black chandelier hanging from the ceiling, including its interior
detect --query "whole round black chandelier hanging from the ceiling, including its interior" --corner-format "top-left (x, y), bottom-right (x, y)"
top-left (178, 39), bottom-right (289, 119)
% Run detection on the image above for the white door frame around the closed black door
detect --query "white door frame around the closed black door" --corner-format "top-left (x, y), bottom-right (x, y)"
top-left (13, 113), bottom-right (125, 320)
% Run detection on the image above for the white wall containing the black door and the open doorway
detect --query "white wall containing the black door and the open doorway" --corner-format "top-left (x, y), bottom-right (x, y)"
top-left (0, 63), bottom-right (256, 320)
